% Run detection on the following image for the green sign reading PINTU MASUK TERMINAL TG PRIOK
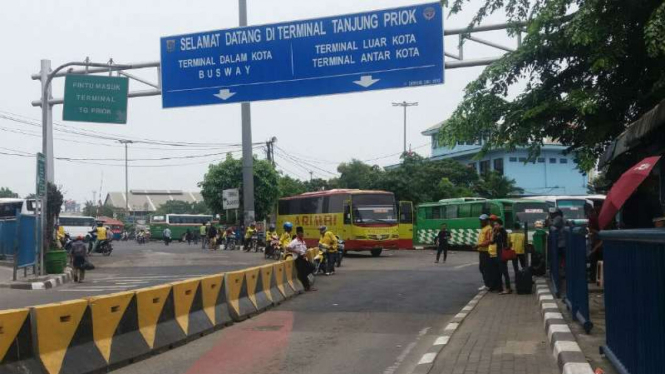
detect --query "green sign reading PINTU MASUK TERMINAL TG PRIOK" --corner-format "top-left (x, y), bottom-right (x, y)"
top-left (62, 74), bottom-right (129, 124)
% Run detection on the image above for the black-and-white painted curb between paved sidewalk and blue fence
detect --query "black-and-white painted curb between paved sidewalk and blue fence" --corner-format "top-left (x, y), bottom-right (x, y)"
top-left (536, 279), bottom-right (593, 374)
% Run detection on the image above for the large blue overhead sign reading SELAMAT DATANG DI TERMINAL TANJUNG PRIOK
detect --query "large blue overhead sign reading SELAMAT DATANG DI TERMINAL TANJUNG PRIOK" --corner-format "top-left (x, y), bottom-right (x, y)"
top-left (161, 2), bottom-right (444, 108)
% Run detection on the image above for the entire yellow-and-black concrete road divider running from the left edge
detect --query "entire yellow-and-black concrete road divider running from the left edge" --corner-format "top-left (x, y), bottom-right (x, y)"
top-left (0, 260), bottom-right (303, 374)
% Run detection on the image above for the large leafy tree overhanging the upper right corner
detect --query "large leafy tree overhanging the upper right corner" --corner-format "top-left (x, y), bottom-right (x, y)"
top-left (440, 0), bottom-right (665, 170)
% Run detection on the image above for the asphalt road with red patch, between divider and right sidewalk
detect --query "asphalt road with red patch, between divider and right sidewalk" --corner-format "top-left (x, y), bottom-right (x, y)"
top-left (109, 251), bottom-right (480, 374)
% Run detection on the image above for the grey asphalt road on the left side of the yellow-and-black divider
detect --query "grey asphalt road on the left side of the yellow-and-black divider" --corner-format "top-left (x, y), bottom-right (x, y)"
top-left (0, 242), bottom-right (269, 309)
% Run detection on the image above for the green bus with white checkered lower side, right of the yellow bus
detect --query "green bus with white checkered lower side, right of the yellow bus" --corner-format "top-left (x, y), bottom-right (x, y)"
top-left (414, 197), bottom-right (548, 246)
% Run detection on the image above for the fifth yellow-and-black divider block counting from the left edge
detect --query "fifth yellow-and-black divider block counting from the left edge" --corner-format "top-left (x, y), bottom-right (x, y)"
top-left (171, 279), bottom-right (215, 338)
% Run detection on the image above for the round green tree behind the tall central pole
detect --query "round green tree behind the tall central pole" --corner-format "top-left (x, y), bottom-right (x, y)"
top-left (198, 155), bottom-right (279, 220)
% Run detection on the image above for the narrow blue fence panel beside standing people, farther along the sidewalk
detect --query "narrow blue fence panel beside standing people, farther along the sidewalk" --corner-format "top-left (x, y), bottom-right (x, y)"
top-left (564, 227), bottom-right (593, 334)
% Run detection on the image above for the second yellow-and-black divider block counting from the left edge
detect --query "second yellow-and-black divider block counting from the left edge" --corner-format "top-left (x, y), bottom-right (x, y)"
top-left (32, 300), bottom-right (106, 374)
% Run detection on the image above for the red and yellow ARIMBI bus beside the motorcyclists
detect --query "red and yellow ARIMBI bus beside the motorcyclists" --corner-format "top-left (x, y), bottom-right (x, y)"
top-left (277, 189), bottom-right (399, 257)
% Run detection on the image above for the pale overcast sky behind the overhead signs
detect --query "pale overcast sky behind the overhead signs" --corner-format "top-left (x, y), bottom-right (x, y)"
top-left (0, 0), bottom-right (514, 202)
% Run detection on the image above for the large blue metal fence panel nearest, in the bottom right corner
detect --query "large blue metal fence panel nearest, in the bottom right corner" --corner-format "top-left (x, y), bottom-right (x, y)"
top-left (600, 229), bottom-right (665, 374)
